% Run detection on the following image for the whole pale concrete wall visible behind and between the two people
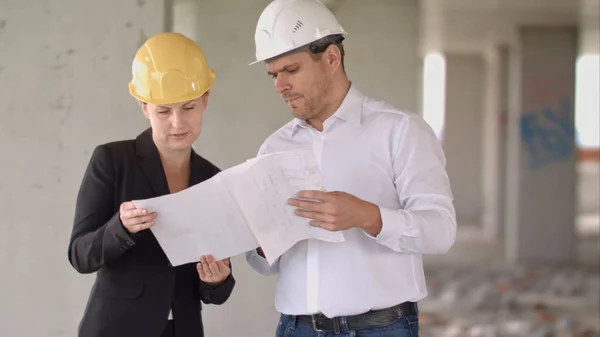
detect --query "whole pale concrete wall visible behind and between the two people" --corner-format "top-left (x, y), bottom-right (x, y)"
top-left (0, 0), bottom-right (419, 337)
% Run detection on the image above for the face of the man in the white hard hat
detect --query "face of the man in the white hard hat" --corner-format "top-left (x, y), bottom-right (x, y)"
top-left (266, 51), bottom-right (330, 120)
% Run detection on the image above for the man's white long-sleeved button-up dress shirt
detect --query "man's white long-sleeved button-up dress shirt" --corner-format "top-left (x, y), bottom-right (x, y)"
top-left (246, 85), bottom-right (456, 317)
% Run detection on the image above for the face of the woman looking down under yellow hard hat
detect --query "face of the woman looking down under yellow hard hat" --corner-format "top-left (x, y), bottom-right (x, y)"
top-left (141, 93), bottom-right (208, 151)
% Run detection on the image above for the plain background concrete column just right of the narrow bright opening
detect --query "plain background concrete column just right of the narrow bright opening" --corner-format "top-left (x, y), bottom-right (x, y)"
top-left (443, 54), bottom-right (485, 226)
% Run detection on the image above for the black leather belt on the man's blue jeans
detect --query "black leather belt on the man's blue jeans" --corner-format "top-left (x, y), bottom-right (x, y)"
top-left (297, 302), bottom-right (418, 333)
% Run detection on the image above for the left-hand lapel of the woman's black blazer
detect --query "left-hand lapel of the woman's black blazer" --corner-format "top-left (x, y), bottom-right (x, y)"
top-left (135, 128), bottom-right (169, 196)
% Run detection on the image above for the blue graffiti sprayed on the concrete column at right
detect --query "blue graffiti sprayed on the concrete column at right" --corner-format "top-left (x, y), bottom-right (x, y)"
top-left (521, 98), bottom-right (575, 169)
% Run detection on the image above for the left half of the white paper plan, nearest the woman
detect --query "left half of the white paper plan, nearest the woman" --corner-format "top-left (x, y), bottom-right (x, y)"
top-left (134, 175), bottom-right (258, 266)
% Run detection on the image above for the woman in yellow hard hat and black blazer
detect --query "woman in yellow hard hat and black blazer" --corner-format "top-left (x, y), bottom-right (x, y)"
top-left (69, 33), bottom-right (235, 337)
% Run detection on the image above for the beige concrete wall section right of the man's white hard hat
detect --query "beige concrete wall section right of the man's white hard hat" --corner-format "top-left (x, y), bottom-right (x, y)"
top-left (333, 0), bottom-right (422, 112)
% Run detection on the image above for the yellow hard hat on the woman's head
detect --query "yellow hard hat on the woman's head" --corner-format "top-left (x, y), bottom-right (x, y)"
top-left (129, 33), bottom-right (215, 105)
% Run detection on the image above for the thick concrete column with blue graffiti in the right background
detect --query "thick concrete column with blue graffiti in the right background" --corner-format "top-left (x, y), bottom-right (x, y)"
top-left (506, 27), bottom-right (577, 264)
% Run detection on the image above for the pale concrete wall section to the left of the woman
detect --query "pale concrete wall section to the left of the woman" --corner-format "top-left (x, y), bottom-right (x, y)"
top-left (0, 0), bottom-right (167, 337)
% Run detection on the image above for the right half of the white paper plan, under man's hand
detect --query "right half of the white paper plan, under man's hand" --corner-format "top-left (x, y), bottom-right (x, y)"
top-left (231, 150), bottom-right (344, 263)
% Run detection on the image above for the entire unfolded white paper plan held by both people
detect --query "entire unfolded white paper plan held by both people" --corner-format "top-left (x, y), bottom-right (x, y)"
top-left (134, 149), bottom-right (344, 266)
